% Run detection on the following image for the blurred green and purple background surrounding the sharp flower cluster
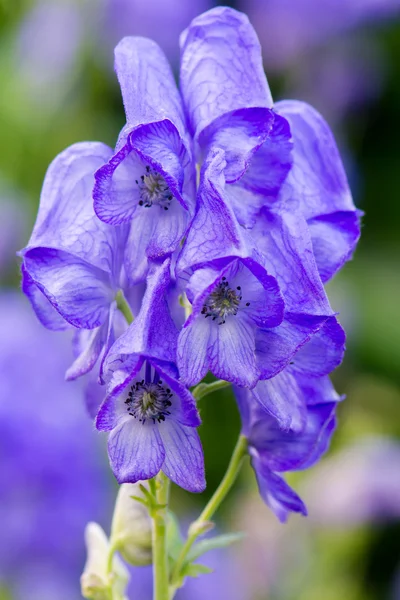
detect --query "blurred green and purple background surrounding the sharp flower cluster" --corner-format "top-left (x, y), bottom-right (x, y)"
top-left (0, 0), bottom-right (400, 600)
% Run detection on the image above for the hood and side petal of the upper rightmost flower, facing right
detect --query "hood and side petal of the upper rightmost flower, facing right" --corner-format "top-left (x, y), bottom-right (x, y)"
top-left (275, 100), bottom-right (360, 282)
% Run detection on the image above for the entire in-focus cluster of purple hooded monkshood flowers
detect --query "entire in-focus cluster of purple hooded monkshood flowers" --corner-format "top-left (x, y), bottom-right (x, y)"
top-left (21, 7), bottom-right (360, 520)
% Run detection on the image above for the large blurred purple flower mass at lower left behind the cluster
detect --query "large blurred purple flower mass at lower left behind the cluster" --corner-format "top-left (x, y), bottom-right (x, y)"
top-left (0, 292), bottom-right (111, 600)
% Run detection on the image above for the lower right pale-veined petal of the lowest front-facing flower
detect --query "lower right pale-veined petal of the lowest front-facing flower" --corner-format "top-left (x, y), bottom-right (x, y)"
top-left (159, 420), bottom-right (206, 492)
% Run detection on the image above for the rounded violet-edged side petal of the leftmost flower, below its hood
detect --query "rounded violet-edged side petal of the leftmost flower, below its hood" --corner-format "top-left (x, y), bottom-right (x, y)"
top-left (24, 248), bottom-right (113, 329)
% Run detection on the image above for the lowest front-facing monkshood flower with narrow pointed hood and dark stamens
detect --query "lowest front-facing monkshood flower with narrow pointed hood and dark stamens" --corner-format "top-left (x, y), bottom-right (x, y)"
top-left (96, 259), bottom-right (205, 492)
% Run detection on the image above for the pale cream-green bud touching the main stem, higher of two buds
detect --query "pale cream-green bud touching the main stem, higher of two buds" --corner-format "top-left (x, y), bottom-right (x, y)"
top-left (111, 482), bottom-right (152, 566)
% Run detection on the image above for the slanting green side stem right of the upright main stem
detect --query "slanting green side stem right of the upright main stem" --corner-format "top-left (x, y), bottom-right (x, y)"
top-left (171, 436), bottom-right (247, 597)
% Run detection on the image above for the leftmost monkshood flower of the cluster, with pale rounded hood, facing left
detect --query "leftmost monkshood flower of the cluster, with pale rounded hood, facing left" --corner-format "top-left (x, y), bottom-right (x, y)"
top-left (20, 142), bottom-right (128, 379)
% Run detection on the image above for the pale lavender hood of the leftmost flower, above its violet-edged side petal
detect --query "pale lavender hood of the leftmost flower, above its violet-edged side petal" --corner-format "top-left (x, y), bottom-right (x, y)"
top-left (23, 142), bottom-right (125, 275)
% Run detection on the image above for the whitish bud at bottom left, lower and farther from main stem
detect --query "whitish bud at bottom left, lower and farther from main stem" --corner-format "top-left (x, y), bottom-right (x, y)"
top-left (81, 522), bottom-right (129, 600)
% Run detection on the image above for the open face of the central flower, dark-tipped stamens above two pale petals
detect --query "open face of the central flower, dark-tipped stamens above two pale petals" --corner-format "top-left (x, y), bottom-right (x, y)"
top-left (178, 257), bottom-right (283, 387)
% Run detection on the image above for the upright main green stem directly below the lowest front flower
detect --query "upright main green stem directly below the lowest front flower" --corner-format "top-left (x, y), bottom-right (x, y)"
top-left (152, 472), bottom-right (169, 600)
